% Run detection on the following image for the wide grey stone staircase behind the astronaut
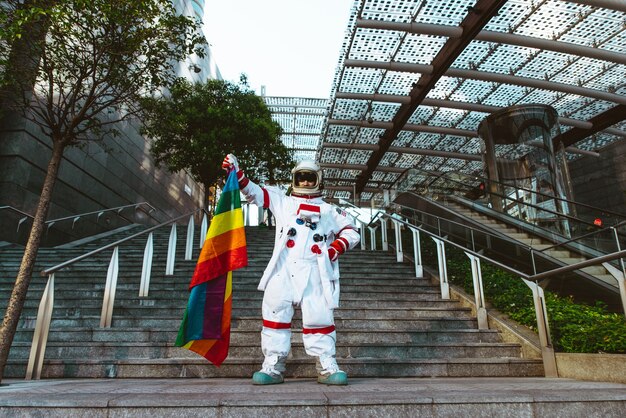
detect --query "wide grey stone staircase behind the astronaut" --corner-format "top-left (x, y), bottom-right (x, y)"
top-left (0, 228), bottom-right (543, 378)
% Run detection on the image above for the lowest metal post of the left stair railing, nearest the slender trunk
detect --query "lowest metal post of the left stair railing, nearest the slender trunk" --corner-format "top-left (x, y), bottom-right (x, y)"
top-left (25, 273), bottom-right (54, 380)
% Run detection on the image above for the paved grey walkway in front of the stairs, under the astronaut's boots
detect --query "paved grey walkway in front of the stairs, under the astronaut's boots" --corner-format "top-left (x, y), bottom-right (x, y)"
top-left (0, 378), bottom-right (626, 418)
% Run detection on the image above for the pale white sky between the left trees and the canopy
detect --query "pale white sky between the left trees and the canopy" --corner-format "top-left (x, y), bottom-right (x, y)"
top-left (204, 0), bottom-right (353, 98)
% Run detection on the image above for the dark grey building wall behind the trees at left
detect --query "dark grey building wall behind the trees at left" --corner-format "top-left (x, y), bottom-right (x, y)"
top-left (0, 116), bottom-right (204, 242)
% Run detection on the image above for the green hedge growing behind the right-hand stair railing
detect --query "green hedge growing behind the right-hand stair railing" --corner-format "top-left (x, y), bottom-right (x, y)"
top-left (414, 235), bottom-right (626, 354)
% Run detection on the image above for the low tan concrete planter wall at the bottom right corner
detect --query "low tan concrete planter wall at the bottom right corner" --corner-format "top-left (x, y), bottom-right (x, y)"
top-left (556, 353), bottom-right (626, 383)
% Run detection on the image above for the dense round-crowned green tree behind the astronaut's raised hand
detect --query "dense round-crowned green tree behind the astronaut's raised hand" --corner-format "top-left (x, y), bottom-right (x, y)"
top-left (143, 76), bottom-right (293, 204)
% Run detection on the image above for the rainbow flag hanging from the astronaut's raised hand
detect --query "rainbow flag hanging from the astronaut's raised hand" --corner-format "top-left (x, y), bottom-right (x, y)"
top-left (176, 170), bottom-right (248, 367)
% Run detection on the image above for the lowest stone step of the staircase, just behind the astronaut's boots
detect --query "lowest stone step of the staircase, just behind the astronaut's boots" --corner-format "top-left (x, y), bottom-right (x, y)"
top-left (5, 356), bottom-right (543, 379)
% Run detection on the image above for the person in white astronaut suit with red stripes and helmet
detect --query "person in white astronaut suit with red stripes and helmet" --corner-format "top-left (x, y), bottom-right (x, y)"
top-left (222, 154), bottom-right (360, 385)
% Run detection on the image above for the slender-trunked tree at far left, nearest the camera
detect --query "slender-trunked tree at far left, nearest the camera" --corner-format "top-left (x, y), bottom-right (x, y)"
top-left (0, 0), bottom-right (206, 379)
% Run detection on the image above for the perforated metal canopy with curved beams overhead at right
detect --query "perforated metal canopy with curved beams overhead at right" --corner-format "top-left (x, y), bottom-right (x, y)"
top-left (266, 0), bottom-right (626, 199)
